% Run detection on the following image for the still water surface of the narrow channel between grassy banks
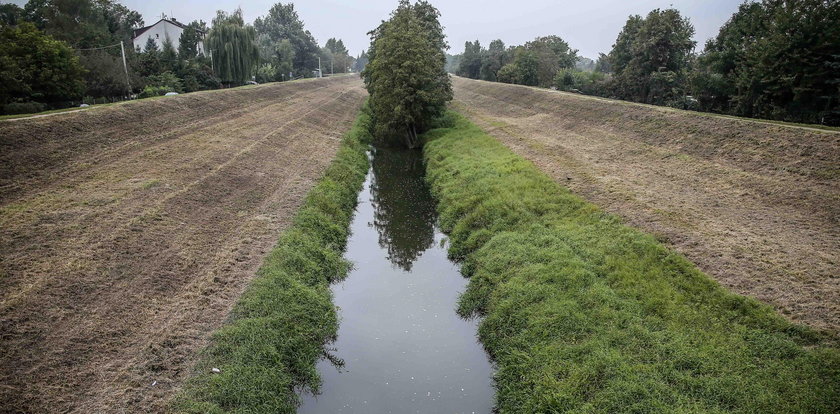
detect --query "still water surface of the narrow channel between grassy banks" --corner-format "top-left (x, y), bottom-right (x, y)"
top-left (298, 149), bottom-right (494, 414)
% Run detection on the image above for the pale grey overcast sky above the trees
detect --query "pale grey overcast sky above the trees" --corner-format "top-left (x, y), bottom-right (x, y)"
top-left (4, 0), bottom-right (742, 58)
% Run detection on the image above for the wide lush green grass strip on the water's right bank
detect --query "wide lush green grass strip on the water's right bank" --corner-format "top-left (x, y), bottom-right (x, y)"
top-left (424, 114), bottom-right (840, 413)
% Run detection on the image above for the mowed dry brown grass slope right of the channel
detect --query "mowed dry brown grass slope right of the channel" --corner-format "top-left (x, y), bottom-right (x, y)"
top-left (453, 77), bottom-right (840, 334)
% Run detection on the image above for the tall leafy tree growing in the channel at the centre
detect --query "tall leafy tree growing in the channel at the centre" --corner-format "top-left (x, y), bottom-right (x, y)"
top-left (363, 0), bottom-right (452, 148)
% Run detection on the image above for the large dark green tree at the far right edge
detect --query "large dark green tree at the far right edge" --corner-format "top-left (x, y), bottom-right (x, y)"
top-left (692, 0), bottom-right (840, 124)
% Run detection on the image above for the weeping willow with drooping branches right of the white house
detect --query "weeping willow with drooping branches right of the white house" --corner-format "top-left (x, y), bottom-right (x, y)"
top-left (207, 9), bottom-right (260, 85)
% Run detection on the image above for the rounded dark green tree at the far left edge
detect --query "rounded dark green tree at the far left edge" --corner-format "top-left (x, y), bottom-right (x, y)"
top-left (0, 22), bottom-right (85, 104)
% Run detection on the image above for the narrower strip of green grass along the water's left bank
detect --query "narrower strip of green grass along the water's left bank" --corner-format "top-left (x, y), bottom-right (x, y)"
top-left (173, 106), bottom-right (369, 413)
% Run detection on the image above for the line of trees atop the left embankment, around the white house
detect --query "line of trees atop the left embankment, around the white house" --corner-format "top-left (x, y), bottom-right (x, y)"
top-left (0, 0), bottom-right (367, 114)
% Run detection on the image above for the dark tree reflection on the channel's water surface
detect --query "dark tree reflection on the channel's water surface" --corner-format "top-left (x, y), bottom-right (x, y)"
top-left (370, 149), bottom-right (437, 271)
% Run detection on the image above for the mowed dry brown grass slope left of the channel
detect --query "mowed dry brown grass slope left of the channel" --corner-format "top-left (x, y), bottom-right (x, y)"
top-left (0, 76), bottom-right (366, 413)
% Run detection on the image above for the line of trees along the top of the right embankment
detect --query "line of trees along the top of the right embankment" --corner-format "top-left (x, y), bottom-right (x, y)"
top-left (447, 0), bottom-right (840, 125)
